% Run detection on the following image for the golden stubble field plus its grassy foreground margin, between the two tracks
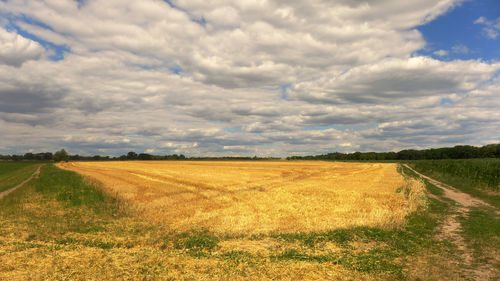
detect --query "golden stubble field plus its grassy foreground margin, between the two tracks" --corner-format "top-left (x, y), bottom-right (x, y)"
top-left (0, 161), bottom-right (498, 280)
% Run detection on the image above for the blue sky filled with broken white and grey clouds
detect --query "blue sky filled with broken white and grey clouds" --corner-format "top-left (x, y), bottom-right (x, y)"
top-left (0, 0), bottom-right (500, 157)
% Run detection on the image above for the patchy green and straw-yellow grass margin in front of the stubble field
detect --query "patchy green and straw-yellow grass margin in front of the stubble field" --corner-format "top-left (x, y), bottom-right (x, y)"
top-left (0, 162), bottom-right (482, 280)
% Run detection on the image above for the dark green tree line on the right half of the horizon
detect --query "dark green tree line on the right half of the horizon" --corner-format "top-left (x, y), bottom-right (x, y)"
top-left (287, 144), bottom-right (500, 160)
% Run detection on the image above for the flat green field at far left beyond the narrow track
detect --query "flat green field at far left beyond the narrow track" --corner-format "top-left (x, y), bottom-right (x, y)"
top-left (0, 162), bottom-right (41, 192)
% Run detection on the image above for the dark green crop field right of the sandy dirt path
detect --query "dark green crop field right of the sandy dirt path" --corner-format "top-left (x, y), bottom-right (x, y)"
top-left (411, 159), bottom-right (500, 208)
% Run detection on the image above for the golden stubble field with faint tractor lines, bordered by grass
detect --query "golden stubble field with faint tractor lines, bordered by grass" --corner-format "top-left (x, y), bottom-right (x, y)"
top-left (58, 161), bottom-right (414, 234)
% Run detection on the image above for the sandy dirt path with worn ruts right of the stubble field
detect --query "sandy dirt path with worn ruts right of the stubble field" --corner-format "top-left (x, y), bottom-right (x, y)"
top-left (403, 164), bottom-right (500, 280)
